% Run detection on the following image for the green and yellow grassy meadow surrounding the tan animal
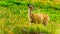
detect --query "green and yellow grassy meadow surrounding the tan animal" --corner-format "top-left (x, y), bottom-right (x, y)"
top-left (0, 0), bottom-right (60, 34)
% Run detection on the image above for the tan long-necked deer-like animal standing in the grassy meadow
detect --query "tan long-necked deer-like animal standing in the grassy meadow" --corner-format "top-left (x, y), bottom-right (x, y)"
top-left (28, 4), bottom-right (49, 25)
